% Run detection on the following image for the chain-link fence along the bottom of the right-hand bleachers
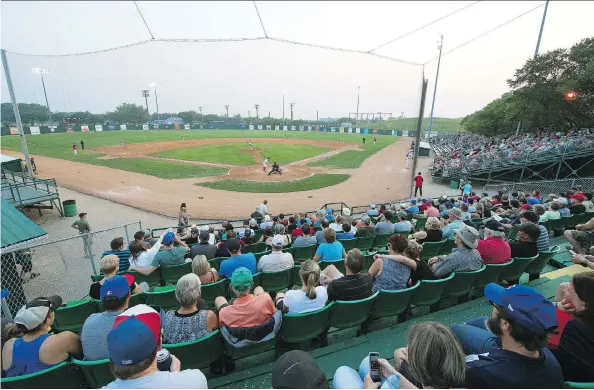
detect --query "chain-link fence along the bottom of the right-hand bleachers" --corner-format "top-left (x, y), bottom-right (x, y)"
top-left (483, 177), bottom-right (594, 197)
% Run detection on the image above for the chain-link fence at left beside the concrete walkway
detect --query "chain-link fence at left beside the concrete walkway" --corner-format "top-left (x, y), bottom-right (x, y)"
top-left (0, 221), bottom-right (142, 316)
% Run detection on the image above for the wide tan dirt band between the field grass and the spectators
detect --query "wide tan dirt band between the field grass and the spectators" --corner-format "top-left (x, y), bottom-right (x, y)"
top-left (3, 138), bottom-right (412, 219)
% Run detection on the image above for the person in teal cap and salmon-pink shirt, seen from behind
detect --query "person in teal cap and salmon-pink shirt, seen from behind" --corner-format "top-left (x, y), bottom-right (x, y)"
top-left (215, 267), bottom-right (276, 328)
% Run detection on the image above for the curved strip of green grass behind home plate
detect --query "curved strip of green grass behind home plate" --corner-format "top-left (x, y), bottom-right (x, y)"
top-left (199, 173), bottom-right (351, 193)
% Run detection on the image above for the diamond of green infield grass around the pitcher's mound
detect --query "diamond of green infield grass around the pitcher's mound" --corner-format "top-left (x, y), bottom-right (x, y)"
top-left (152, 141), bottom-right (332, 166)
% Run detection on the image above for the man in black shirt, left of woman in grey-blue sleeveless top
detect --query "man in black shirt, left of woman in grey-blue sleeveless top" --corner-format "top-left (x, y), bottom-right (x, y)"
top-left (324, 248), bottom-right (373, 301)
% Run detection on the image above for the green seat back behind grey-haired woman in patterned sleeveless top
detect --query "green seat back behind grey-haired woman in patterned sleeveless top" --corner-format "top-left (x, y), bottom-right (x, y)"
top-left (163, 329), bottom-right (223, 370)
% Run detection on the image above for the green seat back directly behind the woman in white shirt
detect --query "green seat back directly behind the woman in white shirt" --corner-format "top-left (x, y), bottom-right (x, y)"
top-left (277, 302), bottom-right (334, 343)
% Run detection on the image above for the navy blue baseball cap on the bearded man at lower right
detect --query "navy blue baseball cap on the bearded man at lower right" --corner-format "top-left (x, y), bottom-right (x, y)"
top-left (485, 283), bottom-right (559, 334)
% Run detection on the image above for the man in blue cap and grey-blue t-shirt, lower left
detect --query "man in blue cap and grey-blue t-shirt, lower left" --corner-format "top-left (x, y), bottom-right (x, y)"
top-left (80, 275), bottom-right (131, 360)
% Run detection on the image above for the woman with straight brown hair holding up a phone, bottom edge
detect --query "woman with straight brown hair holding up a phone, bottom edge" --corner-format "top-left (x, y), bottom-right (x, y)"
top-left (332, 321), bottom-right (465, 389)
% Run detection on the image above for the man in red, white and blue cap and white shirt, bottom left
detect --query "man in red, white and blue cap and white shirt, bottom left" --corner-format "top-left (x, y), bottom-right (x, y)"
top-left (104, 305), bottom-right (208, 389)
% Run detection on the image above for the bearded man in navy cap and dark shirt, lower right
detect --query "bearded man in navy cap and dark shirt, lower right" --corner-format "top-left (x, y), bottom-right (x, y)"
top-left (452, 283), bottom-right (563, 389)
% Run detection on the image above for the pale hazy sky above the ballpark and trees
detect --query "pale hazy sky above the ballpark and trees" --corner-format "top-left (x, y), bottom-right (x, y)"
top-left (0, 1), bottom-right (594, 119)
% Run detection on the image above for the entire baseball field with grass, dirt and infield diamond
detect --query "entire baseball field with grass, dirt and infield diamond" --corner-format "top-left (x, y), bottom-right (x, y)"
top-left (2, 130), bottom-right (411, 218)
